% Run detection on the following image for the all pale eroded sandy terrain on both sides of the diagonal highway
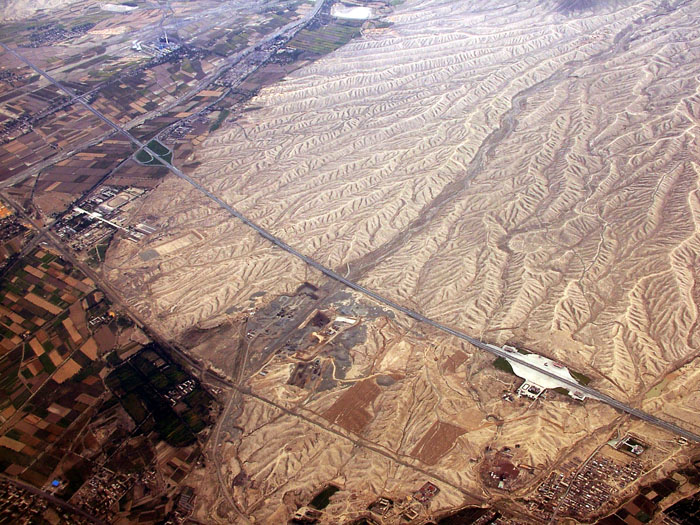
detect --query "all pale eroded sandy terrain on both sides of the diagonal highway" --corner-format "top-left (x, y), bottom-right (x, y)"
top-left (106, 0), bottom-right (700, 519)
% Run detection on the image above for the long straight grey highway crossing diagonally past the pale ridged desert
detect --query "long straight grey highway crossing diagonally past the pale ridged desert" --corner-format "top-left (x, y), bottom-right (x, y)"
top-left (0, 37), bottom-right (700, 443)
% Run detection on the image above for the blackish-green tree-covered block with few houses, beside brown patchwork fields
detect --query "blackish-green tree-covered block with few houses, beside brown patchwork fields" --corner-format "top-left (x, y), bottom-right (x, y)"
top-left (105, 343), bottom-right (212, 447)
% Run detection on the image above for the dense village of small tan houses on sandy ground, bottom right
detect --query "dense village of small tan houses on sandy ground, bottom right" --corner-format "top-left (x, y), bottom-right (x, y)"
top-left (528, 455), bottom-right (643, 519)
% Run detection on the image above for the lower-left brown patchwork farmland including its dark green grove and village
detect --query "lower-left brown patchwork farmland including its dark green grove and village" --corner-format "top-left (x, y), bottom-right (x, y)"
top-left (0, 249), bottom-right (213, 522)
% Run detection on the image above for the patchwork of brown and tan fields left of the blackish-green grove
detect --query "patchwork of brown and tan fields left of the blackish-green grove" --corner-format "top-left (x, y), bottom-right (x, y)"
top-left (0, 250), bottom-right (105, 485)
